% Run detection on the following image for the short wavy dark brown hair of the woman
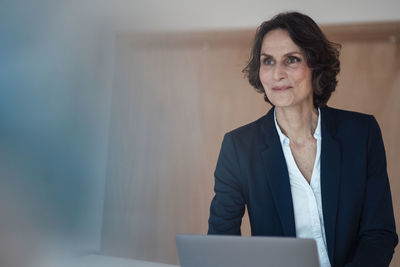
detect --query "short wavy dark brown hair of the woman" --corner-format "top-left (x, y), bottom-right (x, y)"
top-left (242, 12), bottom-right (341, 107)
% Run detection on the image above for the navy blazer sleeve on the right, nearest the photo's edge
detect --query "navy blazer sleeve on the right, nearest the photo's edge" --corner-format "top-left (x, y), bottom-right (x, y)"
top-left (346, 116), bottom-right (398, 267)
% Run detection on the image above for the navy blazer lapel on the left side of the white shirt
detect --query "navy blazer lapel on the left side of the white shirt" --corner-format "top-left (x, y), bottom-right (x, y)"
top-left (261, 108), bottom-right (296, 236)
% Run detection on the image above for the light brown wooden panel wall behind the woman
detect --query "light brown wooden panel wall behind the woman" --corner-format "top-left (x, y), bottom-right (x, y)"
top-left (102, 23), bottom-right (400, 266)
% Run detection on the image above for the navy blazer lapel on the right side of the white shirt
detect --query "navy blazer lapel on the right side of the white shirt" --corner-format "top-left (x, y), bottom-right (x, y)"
top-left (321, 108), bottom-right (341, 264)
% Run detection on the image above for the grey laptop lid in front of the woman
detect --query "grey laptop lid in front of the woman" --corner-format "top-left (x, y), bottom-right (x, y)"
top-left (176, 235), bottom-right (319, 267)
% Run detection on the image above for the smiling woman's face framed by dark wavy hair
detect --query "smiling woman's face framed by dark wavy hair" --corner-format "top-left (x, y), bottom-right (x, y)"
top-left (259, 29), bottom-right (313, 107)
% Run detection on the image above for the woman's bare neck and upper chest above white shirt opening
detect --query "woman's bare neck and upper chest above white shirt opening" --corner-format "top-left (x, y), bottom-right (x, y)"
top-left (275, 105), bottom-right (318, 144)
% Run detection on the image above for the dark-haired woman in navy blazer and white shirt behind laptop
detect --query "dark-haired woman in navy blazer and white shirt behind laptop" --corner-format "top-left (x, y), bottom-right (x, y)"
top-left (208, 12), bottom-right (398, 266)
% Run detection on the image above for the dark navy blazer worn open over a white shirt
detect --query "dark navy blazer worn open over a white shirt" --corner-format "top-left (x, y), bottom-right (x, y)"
top-left (208, 107), bottom-right (398, 267)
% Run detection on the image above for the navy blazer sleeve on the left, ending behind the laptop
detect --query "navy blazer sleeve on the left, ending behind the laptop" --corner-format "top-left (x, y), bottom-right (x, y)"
top-left (208, 133), bottom-right (245, 235)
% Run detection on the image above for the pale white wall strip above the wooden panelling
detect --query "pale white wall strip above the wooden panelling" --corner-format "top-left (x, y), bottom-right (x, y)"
top-left (108, 0), bottom-right (400, 30)
